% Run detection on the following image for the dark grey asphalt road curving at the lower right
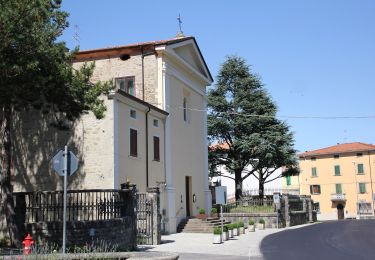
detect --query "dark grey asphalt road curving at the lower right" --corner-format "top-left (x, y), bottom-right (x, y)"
top-left (260, 220), bottom-right (375, 260)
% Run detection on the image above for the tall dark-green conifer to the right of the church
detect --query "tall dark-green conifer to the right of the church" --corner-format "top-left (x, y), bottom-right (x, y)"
top-left (208, 56), bottom-right (296, 199)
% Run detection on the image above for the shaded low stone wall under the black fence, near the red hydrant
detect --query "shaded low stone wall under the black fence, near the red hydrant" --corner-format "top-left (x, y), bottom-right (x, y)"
top-left (25, 216), bottom-right (137, 251)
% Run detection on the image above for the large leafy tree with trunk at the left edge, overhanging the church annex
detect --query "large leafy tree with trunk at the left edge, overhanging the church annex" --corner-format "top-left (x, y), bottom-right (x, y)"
top-left (0, 0), bottom-right (112, 244)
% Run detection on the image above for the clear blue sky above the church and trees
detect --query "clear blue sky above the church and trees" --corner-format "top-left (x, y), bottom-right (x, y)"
top-left (62, 0), bottom-right (375, 151)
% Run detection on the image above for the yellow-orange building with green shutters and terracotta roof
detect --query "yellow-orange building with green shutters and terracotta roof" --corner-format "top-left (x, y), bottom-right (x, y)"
top-left (283, 142), bottom-right (375, 220)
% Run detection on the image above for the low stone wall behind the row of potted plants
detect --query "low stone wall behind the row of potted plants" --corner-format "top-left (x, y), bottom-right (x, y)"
top-left (223, 213), bottom-right (277, 228)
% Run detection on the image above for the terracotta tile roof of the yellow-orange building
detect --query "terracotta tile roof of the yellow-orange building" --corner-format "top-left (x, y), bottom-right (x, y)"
top-left (299, 142), bottom-right (375, 157)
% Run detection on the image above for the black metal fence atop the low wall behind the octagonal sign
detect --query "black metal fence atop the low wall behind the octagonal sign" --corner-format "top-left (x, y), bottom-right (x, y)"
top-left (14, 189), bottom-right (131, 223)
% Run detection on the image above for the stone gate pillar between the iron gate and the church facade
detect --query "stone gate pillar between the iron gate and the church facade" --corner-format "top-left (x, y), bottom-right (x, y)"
top-left (147, 187), bottom-right (161, 245)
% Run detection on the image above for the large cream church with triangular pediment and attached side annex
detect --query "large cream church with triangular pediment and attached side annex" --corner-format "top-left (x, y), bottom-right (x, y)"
top-left (9, 37), bottom-right (213, 233)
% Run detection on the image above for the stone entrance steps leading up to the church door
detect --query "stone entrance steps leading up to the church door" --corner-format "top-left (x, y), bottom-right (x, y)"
top-left (177, 218), bottom-right (230, 233)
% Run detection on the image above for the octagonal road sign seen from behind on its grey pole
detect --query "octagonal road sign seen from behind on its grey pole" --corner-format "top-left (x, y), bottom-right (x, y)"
top-left (52, 145), bottom-right (78, 255)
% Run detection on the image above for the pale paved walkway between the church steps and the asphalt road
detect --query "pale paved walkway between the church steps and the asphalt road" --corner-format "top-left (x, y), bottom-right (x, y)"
top-left (144, 224), bottom-right (318, 260)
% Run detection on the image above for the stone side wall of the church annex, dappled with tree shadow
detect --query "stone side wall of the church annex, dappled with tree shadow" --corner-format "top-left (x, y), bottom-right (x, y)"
top-left (12, 97), bottom-right (114, 192)
